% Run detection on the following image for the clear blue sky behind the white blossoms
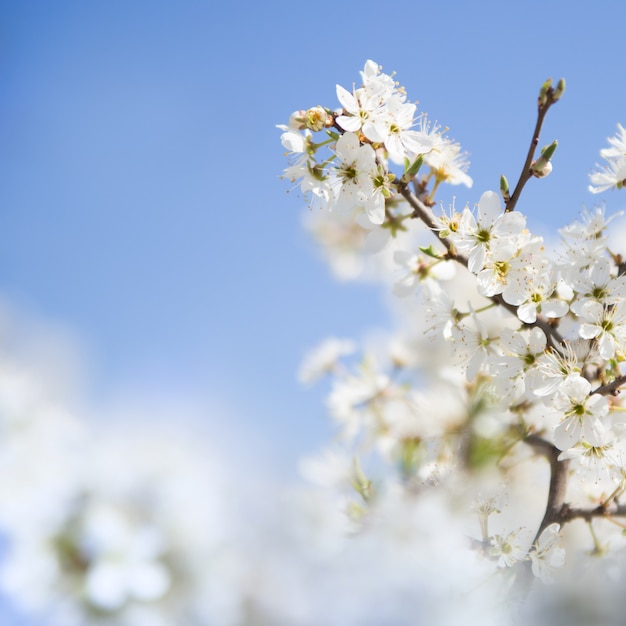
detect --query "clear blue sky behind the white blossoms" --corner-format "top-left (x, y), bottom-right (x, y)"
top-left (0, 0), bottom-right (626, 474)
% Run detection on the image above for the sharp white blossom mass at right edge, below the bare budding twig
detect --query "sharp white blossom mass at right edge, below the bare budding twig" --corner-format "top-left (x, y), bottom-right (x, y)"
top-left (426, 197), bottom-right (626, 460)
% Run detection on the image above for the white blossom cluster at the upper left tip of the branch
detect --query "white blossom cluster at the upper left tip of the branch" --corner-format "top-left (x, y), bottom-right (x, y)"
top-left (279, 61), bottom-right (472, 224)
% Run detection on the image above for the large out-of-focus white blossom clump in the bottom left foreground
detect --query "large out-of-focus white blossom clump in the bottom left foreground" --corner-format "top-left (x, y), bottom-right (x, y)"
top-left (0, 414), bottom-right (241, 626)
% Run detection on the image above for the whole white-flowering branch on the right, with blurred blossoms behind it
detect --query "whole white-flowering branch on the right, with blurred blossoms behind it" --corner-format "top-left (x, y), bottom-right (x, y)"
top-left (279, 61), bottom-right (626, 600)
